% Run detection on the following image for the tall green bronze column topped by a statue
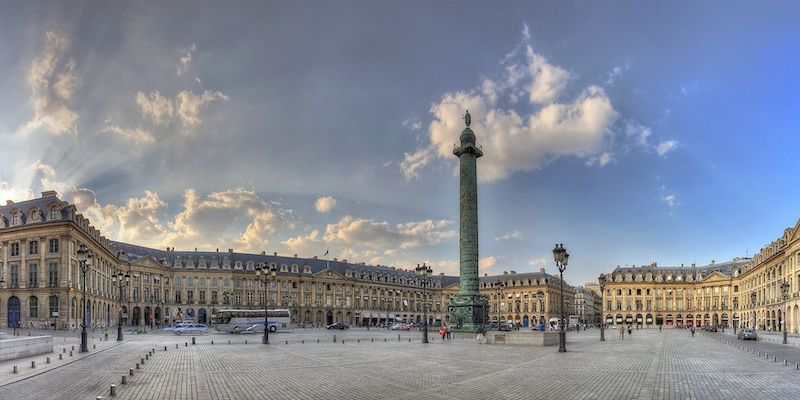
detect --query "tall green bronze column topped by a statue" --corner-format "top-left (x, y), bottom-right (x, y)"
top-left (449, 111), bottom-right (489, 331)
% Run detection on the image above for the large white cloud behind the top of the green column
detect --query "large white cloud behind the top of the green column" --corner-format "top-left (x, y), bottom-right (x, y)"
top-left (400, 43), bottom-right (617, 182)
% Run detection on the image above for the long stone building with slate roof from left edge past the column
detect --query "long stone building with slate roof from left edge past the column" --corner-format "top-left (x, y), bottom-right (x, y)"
top-left (0, 191), bottom-right (574, 329)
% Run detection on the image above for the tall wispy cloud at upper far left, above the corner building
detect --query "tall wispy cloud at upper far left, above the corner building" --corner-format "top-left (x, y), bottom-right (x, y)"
top-left (19, 31), bottom-right (78, 135)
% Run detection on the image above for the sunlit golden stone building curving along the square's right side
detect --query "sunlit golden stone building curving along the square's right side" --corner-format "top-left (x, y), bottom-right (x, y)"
top-left (602, 217), bottom-right (800, 333)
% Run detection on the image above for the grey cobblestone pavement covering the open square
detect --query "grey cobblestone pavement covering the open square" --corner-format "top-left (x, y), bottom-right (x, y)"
top-left (0, 329), bottom-right (800, 400)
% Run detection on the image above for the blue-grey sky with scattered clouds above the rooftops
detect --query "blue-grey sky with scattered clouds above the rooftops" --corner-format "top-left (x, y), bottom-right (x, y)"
top-left (0, 0), bottom-right (800, 285)
